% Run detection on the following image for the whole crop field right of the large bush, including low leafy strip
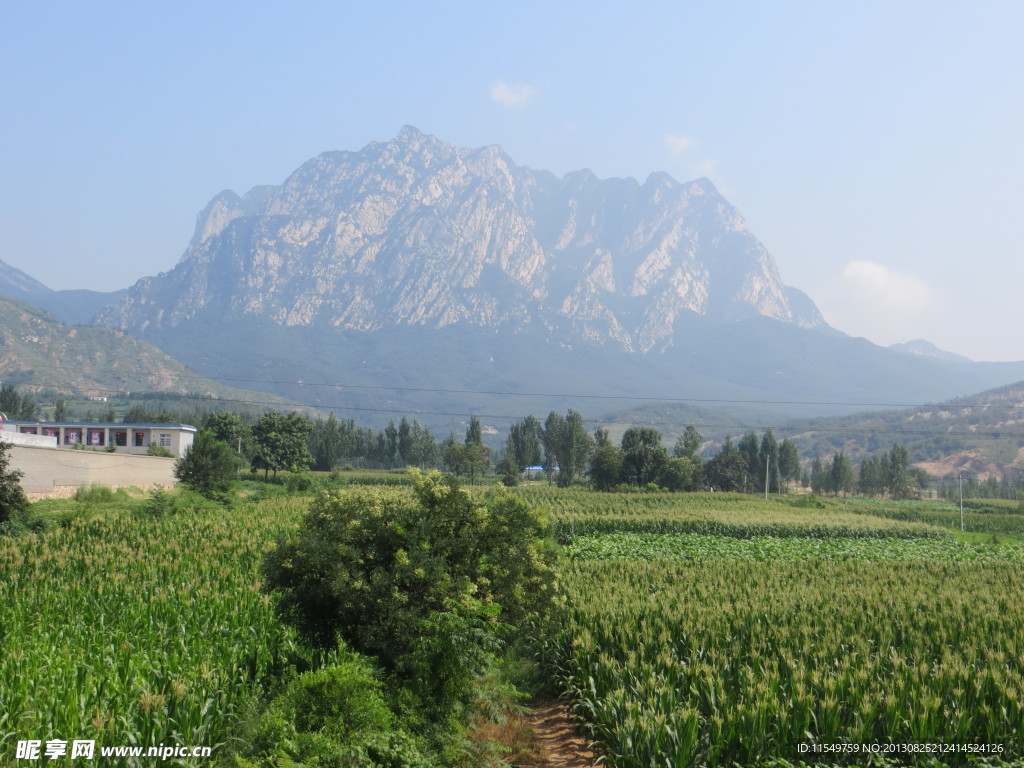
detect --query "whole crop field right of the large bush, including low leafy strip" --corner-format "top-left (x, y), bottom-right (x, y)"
top-left (525, 487), bottom-right (1024, 768)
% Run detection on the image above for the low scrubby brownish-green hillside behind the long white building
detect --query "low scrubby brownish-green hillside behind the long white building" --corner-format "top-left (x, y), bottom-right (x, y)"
top-left (0, 298), bottom-right (288, 408)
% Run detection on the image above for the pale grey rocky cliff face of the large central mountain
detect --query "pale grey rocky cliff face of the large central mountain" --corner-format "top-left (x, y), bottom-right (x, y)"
top-left (96, 127), bottom-right (825, 352)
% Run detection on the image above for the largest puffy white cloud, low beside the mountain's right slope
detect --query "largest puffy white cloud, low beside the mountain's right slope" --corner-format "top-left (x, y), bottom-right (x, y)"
top-left (814, 259), bottom-right (937, 344)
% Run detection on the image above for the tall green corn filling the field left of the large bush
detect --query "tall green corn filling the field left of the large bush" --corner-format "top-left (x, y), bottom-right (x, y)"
top-left (0, 498), bottom-right (304, 765)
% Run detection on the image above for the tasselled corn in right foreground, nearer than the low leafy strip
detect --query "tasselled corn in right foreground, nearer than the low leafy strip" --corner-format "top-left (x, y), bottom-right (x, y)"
top-left (546, 559), bottom-right (1024, 768)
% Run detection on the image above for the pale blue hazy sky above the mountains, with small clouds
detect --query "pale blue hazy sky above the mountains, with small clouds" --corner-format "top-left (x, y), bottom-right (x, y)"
top-left (0, 0), bottom-right (1024, 359)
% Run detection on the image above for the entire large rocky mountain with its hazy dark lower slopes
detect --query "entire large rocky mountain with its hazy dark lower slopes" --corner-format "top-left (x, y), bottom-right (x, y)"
top-left (59, 127), bottom-right (1020, 428)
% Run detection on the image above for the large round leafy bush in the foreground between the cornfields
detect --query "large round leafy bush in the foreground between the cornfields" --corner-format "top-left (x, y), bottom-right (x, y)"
top-left (262, 469), bottom-right (556, 720)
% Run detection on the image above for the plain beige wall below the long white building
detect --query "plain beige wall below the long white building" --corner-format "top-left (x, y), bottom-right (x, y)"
top-left (5, 444), bottom-right (177, 499)
